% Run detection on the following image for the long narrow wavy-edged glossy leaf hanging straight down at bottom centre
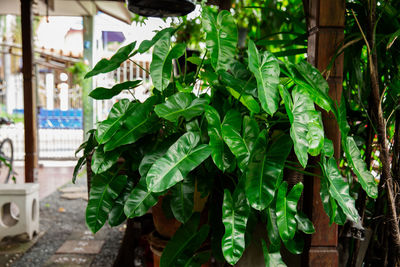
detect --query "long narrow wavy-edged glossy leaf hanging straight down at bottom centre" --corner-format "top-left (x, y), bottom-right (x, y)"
top-left (222, 182), bottom-right (250, 265)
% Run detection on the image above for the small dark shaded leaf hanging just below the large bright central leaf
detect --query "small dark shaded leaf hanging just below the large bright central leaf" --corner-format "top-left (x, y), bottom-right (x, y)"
top-left (170, 178), bottom-right (195, 223)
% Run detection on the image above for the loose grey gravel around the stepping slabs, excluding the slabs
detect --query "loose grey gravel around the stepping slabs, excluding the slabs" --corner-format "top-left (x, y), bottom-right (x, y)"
top-left (12, 178), bottom-right (123, 267)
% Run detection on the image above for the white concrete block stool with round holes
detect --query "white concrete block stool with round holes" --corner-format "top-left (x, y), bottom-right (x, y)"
top-left (0, 183), bottom-right (39, 241)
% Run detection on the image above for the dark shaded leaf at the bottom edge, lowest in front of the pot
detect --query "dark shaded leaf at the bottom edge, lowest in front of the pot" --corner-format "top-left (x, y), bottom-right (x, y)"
top-left (160, 213), bottom-right (210, 267)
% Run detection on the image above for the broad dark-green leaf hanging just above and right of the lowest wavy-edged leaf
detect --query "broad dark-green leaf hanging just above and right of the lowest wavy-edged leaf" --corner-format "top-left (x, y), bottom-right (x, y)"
top-left (246, 131), bottom-right (292, 210)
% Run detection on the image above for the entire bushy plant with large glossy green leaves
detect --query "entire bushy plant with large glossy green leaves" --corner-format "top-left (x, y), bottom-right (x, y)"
top-left (75, 7), bottom-right (377, 266)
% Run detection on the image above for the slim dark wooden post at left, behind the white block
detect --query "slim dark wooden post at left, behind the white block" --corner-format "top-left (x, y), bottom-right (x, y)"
top-left (21, 0), bottom-right (38, 183)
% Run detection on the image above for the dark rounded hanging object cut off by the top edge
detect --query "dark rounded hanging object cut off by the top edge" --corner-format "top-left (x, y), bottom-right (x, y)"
top-left (127, 0), bottom-right (195, 18)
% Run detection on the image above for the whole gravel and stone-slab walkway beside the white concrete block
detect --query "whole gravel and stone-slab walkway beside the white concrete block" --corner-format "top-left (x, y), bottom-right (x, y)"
top-left (0, 167), bottom-right (124, 267)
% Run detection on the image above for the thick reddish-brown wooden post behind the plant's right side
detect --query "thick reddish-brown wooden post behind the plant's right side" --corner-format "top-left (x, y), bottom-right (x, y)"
top-left (304, 0), bottom-right (345, 267)
